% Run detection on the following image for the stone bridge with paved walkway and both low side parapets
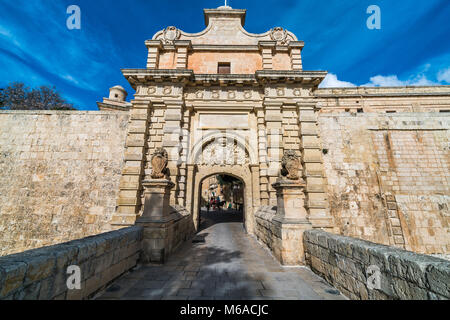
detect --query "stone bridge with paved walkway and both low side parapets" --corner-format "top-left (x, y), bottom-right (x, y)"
top-left (0, 211), bottom-right (450, 300)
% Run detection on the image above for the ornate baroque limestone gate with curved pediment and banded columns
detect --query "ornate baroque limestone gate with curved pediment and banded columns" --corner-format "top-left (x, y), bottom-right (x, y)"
top-left (105, 7), bottom-right (334, 264)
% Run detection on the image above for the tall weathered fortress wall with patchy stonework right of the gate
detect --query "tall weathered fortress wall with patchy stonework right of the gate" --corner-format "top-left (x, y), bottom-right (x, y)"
top-left (319, 113), bottom-right (450, 254)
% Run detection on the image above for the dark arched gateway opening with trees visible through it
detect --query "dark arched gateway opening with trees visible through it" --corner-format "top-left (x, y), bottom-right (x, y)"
top-left (198, 174), bottom-right (246, 231)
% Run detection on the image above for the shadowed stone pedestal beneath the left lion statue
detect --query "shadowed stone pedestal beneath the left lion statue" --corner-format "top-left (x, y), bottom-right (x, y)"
top-left (136, 179), bottom-right (176, 263)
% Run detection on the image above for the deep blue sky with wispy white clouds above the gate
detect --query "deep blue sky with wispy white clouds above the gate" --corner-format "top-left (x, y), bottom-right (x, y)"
top-left (0, 0), bottom-right (450, 110)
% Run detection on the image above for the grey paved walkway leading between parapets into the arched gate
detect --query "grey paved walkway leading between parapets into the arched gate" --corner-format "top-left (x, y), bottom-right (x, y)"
top-left (97, 211), bottom-right (345, 300)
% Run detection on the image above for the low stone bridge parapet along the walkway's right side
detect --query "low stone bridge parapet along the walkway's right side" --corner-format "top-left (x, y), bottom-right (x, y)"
top-left (304, 230), bottom-right (450, 300)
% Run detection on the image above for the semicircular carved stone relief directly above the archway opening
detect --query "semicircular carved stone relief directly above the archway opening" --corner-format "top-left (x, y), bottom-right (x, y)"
top-left (197, 137), bottom-right (250, 165)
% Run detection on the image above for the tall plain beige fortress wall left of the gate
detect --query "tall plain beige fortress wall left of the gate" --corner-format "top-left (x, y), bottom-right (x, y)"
top-left (0, 111), bottom-right (129, 256)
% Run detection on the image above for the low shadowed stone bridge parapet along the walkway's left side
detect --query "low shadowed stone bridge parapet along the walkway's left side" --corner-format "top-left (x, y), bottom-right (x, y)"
top-left (0, 226), bottom-right (143, 300)
